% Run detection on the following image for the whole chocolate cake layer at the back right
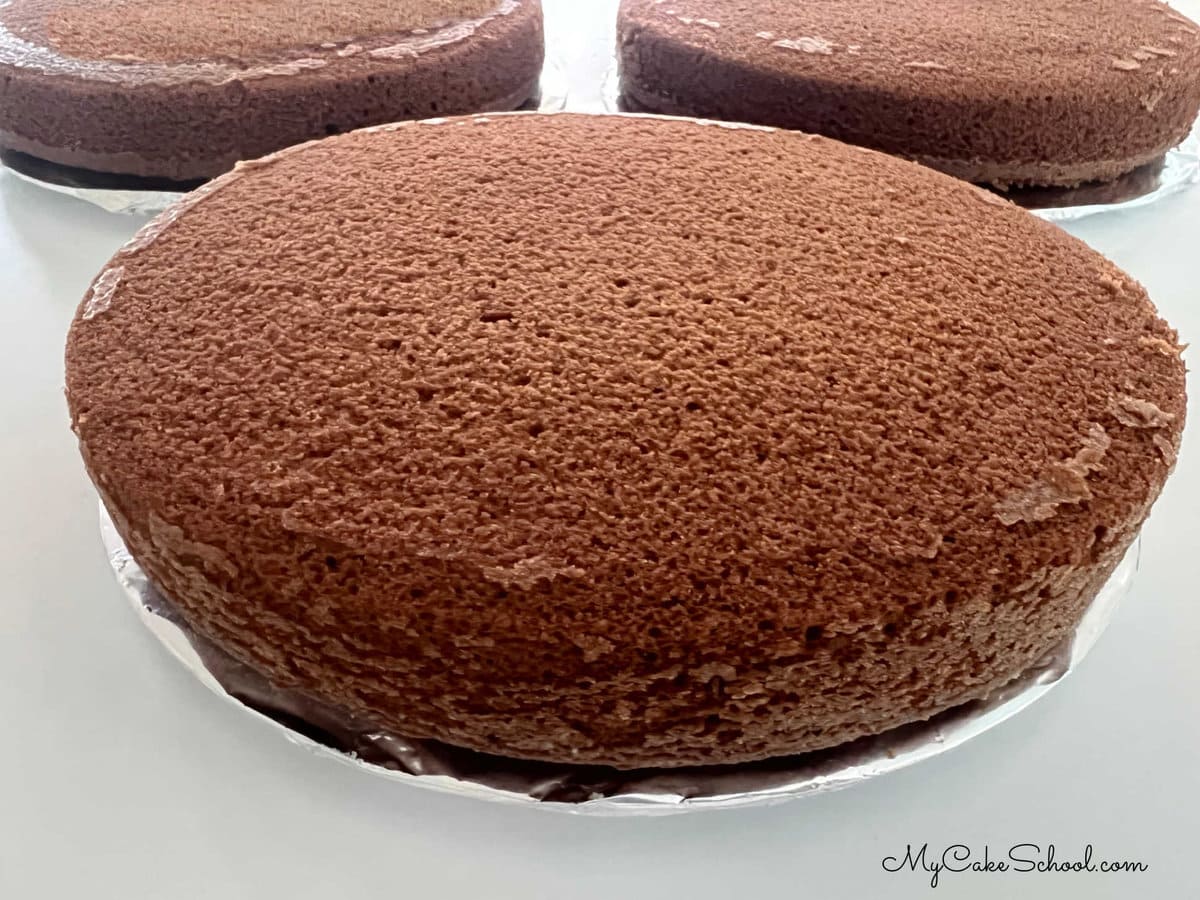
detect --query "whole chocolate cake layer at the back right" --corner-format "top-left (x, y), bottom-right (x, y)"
top-left (618, 0), bottom-right (1200, 187)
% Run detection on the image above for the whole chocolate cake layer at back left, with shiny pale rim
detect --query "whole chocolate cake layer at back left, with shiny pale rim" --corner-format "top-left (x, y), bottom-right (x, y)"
top-left (0, 0), bottom-right (544, 181)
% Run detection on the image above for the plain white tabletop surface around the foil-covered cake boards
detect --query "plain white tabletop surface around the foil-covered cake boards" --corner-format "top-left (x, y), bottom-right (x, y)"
top-left (0, 0), bottom-right (1200, 900)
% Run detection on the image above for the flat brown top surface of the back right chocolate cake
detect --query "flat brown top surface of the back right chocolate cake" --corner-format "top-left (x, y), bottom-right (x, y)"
top-left (623, 0), bottom-right (1200, 102)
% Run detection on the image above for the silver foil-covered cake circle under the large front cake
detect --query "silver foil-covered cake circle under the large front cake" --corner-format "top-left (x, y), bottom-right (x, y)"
top-left (101, 506), bottom-right (1140, 816)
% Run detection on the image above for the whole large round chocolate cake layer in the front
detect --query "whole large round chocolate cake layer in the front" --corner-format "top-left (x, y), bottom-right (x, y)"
top-left (67, 115), bottom-right (1184, 768)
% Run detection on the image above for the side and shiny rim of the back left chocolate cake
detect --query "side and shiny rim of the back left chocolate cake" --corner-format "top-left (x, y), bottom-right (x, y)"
top-left (0, 0), bottom-right (545, 181)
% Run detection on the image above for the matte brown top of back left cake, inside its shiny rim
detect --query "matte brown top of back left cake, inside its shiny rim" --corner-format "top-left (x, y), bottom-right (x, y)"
top-left (0, 0), bottom-right (500, 62)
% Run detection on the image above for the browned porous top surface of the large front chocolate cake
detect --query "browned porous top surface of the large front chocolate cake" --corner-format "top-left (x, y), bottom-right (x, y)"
top-left (67, 115), bottom-right (1184, 654)
